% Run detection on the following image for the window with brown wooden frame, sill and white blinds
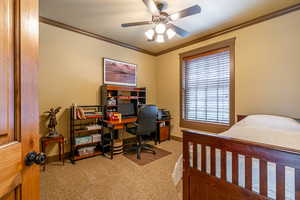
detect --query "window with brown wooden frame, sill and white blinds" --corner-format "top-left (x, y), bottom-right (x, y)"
top-left (181, 39), bottom-right (234, 132)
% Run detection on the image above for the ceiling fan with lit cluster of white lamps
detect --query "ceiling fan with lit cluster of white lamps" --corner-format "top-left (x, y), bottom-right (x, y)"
top-left (121, 0), bottom-right (201, 42)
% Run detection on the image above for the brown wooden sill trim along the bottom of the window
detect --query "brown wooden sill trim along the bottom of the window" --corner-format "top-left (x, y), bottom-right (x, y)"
top-left (180, 119), bottom-right (231, 133)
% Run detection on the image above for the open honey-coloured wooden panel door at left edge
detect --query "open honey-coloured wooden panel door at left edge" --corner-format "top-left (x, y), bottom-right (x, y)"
top-left (0, 0), bottom-right (40, 200)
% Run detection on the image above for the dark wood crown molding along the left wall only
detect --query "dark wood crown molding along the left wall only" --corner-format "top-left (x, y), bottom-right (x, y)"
top-left (40, 16), bottom-right (155, 56)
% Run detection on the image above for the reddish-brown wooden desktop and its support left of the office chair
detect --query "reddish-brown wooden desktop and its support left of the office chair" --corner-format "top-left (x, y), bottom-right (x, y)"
top-left (103, 117), bottom-right (137, 159)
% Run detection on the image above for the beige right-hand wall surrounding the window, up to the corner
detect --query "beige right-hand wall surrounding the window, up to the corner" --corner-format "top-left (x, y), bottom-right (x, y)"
top-left (156, 11), bottom-right (300, 136)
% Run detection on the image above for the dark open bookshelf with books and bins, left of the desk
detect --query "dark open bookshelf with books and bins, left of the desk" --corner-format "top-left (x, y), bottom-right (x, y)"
top-left (70, 105), bottom-right (105, 164)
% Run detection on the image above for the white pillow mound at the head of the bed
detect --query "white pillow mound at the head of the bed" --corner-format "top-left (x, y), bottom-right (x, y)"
top-left (237, 115), bottom-right (300, 131)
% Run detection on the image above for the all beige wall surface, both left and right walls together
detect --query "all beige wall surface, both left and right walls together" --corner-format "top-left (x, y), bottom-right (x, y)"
top-left (39, 11), bottom-right (300, 155)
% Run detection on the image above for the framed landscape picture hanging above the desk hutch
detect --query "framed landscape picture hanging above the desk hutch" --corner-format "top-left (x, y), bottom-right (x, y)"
top-left (103, 58), bottom-right (137, 86)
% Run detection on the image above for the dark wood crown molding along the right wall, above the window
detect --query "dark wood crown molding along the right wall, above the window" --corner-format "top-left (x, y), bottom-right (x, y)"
top-left (155, 3), bottom-right (300, 56)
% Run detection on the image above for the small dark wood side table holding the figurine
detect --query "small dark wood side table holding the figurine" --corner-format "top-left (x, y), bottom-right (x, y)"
top-left (41, 135), bottom-right (65, 171)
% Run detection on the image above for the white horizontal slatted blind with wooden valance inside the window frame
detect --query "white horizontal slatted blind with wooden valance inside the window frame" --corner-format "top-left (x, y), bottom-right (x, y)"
top-left (183, 48), bottom-right (230, 124)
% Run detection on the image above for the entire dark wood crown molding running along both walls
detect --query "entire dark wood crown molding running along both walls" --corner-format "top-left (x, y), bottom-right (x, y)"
top-left (40, 3), bottom-right (300, 56)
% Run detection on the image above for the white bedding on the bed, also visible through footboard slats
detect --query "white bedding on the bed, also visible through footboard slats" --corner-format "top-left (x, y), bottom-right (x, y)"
top-left (172, 115), bottom-right (300, 200)
